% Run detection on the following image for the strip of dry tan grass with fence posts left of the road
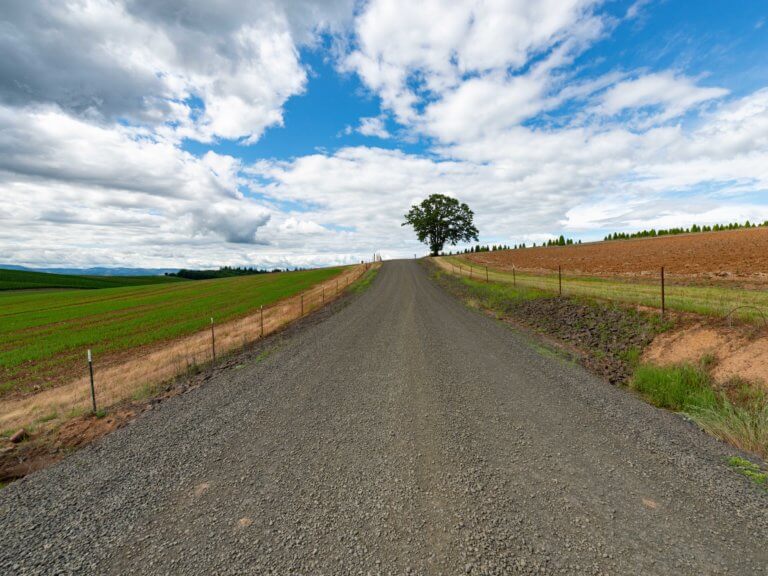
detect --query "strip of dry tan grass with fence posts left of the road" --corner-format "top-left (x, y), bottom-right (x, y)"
top-left (0, 264), bottom-right (371, 429)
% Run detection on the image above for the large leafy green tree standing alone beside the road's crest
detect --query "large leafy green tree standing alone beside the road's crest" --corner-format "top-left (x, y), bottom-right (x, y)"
top-left (402, 194), bottom-right (478, 256)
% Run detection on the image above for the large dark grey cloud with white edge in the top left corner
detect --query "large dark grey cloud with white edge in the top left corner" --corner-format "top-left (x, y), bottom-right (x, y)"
top-left (0, 0), bottom-right (350, 141)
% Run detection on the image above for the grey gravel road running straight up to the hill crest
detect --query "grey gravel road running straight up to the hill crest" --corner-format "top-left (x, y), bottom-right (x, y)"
top-left (0, 261), bottom-right (768, 575)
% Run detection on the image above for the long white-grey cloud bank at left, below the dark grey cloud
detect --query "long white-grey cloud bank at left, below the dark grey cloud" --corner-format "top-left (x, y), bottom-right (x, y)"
top-left (0, 106), bottom-right (269, 252)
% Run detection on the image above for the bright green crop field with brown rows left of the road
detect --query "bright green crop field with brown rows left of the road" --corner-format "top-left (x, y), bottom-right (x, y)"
top-left (0, 268), bottom-right (343, 395)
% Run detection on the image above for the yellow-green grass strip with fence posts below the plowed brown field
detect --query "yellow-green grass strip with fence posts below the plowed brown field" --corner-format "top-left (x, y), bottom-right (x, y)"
top-left (438, 258), bottom-right (768, 324)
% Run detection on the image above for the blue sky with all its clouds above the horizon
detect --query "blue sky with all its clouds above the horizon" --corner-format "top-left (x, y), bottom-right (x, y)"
top-left (0, 0), bottom-right (768, 268)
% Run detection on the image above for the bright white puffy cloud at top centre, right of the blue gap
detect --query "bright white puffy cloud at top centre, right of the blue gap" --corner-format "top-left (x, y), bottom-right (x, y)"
top-left (343, 0), bottom-right (604, 123)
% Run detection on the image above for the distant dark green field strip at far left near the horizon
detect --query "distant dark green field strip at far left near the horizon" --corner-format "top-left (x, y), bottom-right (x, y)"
top-left (0, 269), bottom-right (184, 290)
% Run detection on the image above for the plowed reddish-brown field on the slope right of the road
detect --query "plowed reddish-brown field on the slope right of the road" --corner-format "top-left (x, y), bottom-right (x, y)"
top-left (466, 228), bottom-right (768, 284)
